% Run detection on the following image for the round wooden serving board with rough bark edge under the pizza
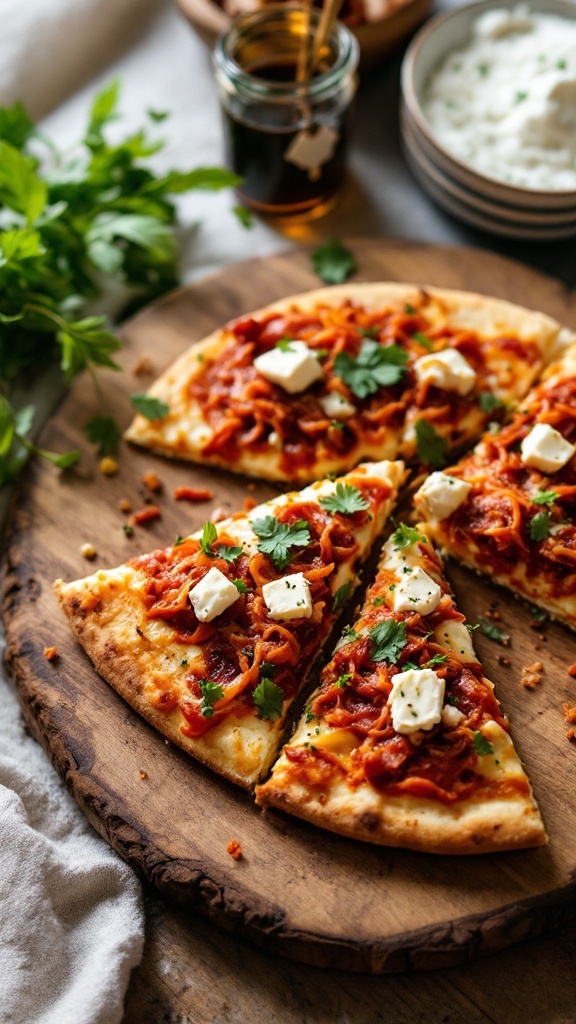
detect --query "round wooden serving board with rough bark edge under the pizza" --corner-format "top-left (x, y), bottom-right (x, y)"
top-left (4, 240), bottom-right (576, 972)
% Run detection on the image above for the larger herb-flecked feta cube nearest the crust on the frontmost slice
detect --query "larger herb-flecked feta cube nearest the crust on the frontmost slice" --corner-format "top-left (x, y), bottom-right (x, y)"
top-left (388, 669), bottom-right (445, 735)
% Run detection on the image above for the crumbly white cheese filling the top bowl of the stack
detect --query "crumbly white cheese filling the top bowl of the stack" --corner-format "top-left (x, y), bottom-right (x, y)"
top-left (422, 4), bottom-right (576, 190)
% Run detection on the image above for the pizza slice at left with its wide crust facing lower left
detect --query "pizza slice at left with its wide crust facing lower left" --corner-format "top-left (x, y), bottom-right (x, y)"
top-left (55, 462), bottom-right (405, 786)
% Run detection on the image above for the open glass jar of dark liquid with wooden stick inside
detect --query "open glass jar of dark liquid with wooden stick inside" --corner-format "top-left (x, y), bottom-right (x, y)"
top-left (213, 3), bottom-right (359, 218)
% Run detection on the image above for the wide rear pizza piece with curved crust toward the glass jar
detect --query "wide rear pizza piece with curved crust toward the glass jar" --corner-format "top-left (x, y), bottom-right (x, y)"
top-left (121, 284), bottom-right (563, 484)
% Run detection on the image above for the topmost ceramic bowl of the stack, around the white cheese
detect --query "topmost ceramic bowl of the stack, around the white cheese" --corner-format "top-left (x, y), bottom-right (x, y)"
top-left (402, 0), bottom-right (576, 216)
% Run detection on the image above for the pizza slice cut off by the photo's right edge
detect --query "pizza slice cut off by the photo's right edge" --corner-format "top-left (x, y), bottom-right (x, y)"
top-left (415, 344), bottom-right (576, 629)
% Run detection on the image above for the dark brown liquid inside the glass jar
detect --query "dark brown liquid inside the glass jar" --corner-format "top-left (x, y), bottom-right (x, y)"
top-left (222, 63), bottom-right (351, 216)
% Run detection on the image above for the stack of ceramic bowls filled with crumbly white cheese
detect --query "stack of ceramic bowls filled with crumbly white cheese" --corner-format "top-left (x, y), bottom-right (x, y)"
top-left (401, 0), bottom-right (576, 241)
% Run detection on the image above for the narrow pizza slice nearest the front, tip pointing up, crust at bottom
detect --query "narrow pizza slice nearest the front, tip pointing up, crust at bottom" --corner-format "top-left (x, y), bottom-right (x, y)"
top-left (256, 524), bottom-right (546, 854)
